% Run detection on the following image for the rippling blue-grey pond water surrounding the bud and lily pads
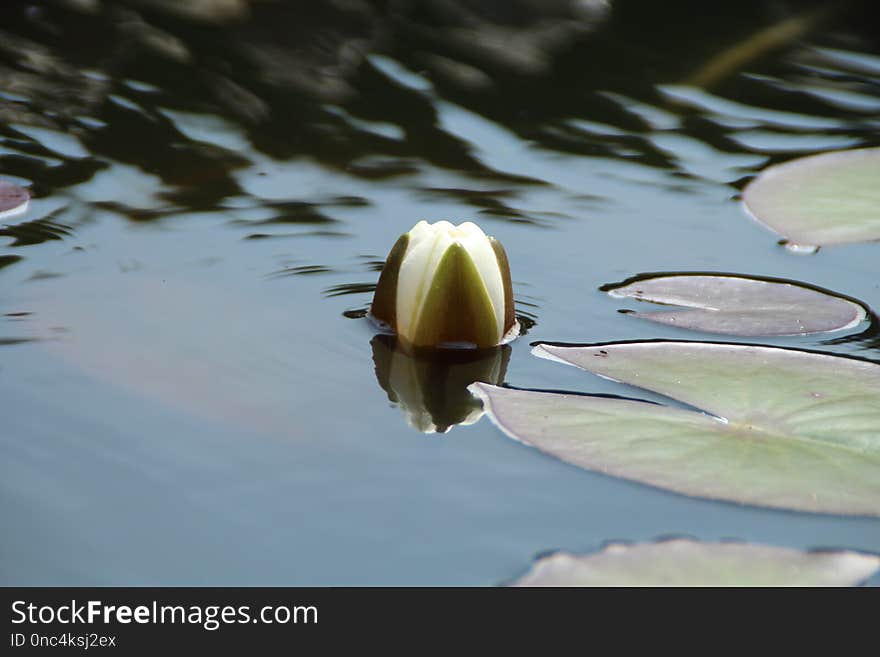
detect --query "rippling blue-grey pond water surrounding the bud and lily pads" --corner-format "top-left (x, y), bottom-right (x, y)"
top-left (0, 0), bottom-right (880, 586)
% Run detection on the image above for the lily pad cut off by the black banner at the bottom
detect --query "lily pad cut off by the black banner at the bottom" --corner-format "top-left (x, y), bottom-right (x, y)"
top-left (515, 539), bottom-right (880, 586)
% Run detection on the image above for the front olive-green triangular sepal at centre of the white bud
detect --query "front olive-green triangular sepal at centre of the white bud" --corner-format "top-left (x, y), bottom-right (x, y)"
top-left (407, 238), bottom-right (501, 347)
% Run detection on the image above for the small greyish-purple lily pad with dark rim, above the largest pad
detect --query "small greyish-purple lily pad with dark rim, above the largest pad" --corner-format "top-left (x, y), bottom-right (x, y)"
top-left (602, 274), bottom-right (867, 335)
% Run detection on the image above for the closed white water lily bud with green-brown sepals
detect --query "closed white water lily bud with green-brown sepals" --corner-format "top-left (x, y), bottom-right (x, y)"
top-left (370, 221), bottom-right (519, 348)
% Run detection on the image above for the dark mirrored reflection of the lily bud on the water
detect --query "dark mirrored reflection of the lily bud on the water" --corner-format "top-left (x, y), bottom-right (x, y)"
top-left (370, 335), bottom-right (511, 433)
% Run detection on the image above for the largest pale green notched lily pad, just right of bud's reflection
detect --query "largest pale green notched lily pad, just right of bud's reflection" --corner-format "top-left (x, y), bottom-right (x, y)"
top-left (471, 341), bottom-right (880, 516)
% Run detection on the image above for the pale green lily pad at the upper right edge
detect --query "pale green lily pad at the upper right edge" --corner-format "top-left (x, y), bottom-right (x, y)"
top-left (743, 148), bottom-right (880, 247)
